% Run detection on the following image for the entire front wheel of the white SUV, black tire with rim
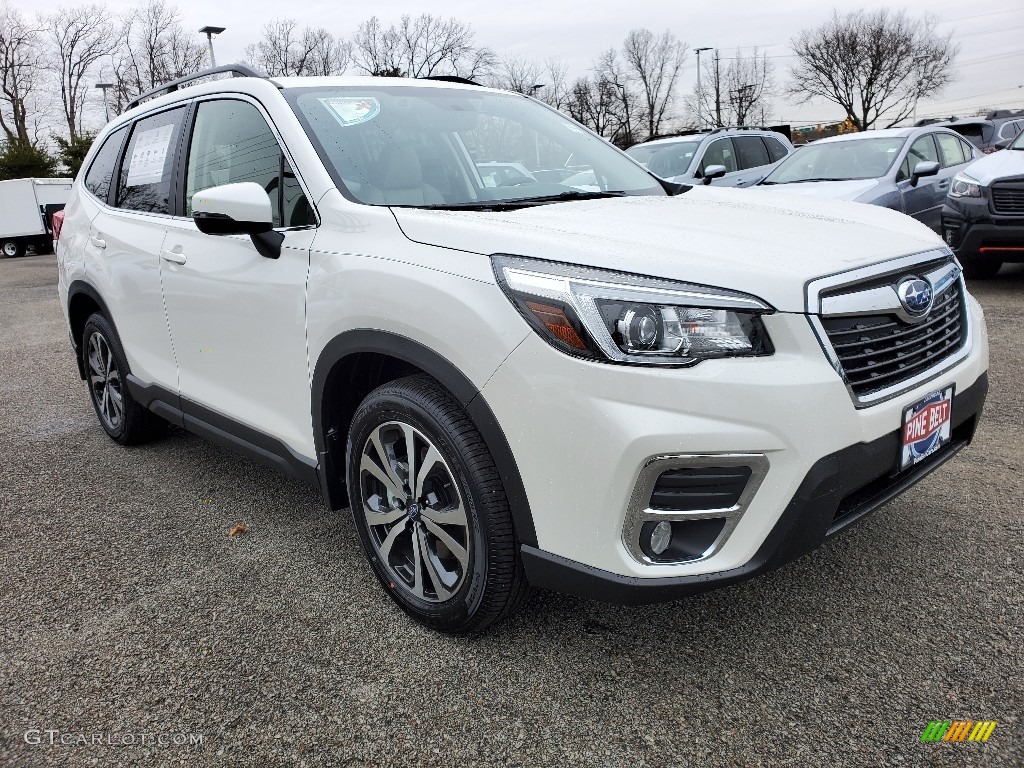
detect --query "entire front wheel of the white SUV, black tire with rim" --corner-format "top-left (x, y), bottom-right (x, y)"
top-left (346, 376), bottom-right (528, 634)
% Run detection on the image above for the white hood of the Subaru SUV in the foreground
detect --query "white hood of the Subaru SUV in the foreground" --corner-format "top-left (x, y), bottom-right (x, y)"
top-left (392, 186), bottom-right (944, 312)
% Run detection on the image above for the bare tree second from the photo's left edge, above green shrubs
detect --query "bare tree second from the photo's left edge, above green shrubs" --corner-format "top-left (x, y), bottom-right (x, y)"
top-left (40, 5), bottom-right (120, 139)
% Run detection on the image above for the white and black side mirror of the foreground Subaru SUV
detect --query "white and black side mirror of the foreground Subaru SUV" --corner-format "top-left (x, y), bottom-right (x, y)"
top-left (193, 181), bottom-right (285, 259)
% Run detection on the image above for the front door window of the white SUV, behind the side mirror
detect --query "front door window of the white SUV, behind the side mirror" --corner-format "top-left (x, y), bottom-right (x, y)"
top-left (185, 99), bottom-right (315, 227)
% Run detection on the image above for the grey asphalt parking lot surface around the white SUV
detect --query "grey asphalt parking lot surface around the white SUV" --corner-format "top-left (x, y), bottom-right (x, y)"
top-left (0, 256), bottom-right (1024, 767)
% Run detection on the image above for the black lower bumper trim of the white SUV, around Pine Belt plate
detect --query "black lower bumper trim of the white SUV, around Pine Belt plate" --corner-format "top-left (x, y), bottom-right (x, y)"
top-left (521, 374), bottom-right (988, 604)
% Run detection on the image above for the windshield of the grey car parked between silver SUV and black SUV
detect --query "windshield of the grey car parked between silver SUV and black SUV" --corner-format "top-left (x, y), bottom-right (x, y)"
top-left (762, 138), bottom-right (906, 184)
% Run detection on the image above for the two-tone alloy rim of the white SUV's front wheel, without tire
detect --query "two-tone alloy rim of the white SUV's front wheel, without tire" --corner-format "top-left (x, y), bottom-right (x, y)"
top-left (359, 421), bottom-right (471, 603)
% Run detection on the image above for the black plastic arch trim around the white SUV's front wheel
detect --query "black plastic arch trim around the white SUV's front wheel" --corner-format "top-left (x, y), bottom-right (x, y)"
top-left (312, 329), bottom-right (537, 547)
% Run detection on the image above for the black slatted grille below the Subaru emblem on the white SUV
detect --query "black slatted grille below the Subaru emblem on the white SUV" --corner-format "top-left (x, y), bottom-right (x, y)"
top-left (821, 281), bottom-right (967, 397)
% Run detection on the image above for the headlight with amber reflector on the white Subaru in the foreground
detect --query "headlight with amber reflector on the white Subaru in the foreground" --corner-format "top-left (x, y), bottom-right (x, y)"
top-left (492, 254), bottom-right (774, 366)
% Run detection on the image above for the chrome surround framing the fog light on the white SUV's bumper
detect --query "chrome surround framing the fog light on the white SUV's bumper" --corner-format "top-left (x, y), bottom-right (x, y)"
top-left (623, 454), bottom-right (769, 565)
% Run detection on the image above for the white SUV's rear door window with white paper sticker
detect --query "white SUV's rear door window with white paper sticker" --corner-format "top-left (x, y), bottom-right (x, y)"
top-left (115, 106), bottom-right (185, 213)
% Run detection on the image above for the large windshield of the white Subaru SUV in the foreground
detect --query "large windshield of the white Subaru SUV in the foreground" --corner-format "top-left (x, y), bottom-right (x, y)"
top-left (285, 83), bottom-right (667, 208)
